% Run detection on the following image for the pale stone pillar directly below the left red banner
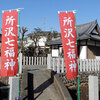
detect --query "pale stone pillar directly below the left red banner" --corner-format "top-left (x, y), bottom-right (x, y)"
top-left (9, 77), bottom-right (19, 100)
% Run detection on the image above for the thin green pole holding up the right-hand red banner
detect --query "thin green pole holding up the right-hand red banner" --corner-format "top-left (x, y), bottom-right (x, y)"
top-left (73, 11), bottom-right (80, 100)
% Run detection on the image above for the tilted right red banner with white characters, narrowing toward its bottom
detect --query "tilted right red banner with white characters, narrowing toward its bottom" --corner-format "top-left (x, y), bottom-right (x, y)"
top-left (59, 12), bottom-right (78, 79)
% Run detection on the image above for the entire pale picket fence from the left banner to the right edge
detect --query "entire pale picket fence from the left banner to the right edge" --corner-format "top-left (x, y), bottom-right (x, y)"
top-left (22, 54), bottom-right (100, 73)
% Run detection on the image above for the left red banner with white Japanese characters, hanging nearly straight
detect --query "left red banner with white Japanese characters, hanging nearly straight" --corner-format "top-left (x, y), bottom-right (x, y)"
top-left (1, 11), bottom-right (18, 77)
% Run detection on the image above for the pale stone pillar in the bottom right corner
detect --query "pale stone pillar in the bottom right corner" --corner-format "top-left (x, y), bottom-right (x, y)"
top-left (89, 75), bottom-right (99, 100)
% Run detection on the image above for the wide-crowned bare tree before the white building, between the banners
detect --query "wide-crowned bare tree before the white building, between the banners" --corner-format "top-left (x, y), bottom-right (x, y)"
top-left (28, 28), bottom-right (60, 56)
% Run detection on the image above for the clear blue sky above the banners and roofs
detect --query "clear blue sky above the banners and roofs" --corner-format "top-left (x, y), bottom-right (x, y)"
top-left (0, 0), bottom-right (100, 34)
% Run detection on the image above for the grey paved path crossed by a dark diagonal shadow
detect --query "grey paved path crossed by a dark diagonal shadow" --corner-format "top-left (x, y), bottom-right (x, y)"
top-left (29, 70), bottom-right (61, 100)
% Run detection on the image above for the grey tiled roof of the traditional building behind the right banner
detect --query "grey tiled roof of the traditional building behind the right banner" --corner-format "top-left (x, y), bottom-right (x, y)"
top-left (48, 20), bottom-right (100, 45)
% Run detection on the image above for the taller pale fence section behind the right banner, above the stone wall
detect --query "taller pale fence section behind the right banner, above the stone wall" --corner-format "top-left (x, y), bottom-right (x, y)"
top-left (47, 55), bottom-right (100, 73)
